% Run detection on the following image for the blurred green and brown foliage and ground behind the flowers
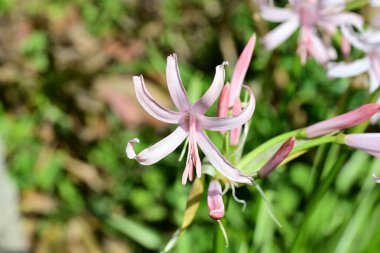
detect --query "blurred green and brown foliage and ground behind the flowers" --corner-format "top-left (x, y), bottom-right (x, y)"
top-left (0, 0), bottom-right (380, 253)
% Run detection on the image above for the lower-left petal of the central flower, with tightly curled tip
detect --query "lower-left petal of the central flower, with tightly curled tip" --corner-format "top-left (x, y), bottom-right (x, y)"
top-left (126, 127), bottom-right (187, 165)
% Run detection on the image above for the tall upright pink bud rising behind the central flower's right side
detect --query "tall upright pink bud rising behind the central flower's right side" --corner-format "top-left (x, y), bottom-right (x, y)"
top-left (228, 34), bottom-right (256, 107)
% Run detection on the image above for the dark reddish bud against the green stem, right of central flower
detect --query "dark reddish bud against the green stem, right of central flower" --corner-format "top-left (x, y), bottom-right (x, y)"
top-left (259, 137), bottom-right (296, 178)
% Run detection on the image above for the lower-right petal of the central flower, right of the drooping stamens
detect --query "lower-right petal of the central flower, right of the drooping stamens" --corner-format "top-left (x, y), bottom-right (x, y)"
top-left (197, 132), bottom-right (252, 184)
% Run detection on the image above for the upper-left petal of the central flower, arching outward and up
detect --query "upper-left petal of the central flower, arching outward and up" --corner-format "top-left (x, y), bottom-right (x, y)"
top-left (133, 76), bottom-right (181, 124)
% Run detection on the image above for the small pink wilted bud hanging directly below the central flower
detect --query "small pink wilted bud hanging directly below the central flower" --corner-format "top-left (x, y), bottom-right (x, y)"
top-left (207, 179), bottom-right (224, 220)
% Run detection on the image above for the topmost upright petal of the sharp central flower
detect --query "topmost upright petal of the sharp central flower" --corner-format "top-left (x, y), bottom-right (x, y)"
top-left (166, 54), bottom-right (190, 111)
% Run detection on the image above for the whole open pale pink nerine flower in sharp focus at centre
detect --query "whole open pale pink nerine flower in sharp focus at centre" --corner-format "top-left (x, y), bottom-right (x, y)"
top-left (126, 54), bottom-right (255, 184)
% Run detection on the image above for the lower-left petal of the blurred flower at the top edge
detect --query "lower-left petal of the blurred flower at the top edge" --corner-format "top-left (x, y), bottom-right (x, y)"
top-left (263, 18), bottom-right (299, 50)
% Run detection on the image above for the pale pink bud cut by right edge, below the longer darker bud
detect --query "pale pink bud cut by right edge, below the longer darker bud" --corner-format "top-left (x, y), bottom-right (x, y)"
top-left (344, 133), bottom-right (380, 157)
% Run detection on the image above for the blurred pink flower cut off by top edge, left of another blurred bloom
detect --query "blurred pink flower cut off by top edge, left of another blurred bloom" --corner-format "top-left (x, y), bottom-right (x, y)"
top-left (260, 0), bottom-right (363, 64)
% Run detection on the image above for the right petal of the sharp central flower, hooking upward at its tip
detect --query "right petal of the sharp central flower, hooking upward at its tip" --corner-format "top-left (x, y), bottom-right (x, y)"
top-left (198, 86), bottom-right (256, 131)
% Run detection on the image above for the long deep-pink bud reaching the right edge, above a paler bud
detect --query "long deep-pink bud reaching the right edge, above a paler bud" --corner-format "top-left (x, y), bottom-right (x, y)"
top-left (306, 103), bottom-right (380, 138)
